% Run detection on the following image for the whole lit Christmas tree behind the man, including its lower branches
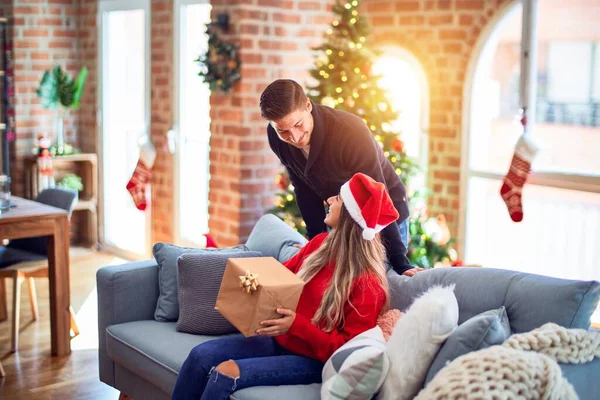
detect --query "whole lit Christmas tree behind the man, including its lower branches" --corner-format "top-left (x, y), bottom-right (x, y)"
top-left (269, 0), bottom-right (449, 268)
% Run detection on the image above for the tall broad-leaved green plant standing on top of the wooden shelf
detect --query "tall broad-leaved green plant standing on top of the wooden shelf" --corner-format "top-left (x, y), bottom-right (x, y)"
top-left (36, 65), bottom-right (88, 155)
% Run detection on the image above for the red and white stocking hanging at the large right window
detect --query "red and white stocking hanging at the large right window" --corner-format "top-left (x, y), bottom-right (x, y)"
top-left (500, 134), bottom-right (538, 222)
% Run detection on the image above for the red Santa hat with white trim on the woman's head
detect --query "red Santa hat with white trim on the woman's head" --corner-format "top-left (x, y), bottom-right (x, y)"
top-left (340, 172), bottom-right (399, 240)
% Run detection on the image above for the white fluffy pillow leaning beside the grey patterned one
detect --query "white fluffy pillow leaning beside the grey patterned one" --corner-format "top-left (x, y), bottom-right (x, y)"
top-left (378, 285), bottom-right (458, 400)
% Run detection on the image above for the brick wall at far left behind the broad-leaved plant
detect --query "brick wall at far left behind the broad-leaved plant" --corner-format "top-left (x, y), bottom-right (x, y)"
top-left (11, 0), bottom-right (79, 195)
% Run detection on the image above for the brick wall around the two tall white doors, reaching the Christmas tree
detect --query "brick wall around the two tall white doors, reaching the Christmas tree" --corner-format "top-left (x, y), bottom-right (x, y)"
top-left (77, 0), bottom-right (332, 245)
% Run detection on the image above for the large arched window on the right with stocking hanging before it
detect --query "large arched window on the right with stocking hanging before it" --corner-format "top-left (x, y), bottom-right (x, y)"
top-left (461, 1), bottom-right (600, 324)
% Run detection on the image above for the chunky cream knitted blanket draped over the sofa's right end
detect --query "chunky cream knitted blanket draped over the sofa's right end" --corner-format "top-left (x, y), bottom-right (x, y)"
top-left (416, 323), bottom-right (600, 400)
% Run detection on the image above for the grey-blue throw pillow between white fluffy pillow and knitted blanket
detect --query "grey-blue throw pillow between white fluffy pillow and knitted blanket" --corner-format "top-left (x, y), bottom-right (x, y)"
top-left (425, 307), bottom-right (510, 384)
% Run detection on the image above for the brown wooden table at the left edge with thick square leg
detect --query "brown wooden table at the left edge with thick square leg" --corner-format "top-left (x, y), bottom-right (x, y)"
top-left (0, 196), bottom-right (71, 356)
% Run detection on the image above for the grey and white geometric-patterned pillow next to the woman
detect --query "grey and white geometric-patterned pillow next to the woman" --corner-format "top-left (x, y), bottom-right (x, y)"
top-left (321, 326), bottom-right (389, 400)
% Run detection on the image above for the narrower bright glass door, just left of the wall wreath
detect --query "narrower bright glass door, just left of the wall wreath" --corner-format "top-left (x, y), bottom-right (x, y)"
top-left (171, 0), bottom-right (211, 247)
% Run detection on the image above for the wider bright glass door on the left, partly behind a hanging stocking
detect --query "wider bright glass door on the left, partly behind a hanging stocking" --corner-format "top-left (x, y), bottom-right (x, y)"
top-left (98, 0), bottom-right (151, 258)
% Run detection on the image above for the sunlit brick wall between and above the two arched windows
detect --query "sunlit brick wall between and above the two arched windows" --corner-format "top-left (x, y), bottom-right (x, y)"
top-left (363, 0), bottom-right (508, 241)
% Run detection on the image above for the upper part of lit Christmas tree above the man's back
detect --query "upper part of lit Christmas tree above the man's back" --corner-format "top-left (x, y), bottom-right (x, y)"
top-left (308, 0), bottom-right (418, 182)
